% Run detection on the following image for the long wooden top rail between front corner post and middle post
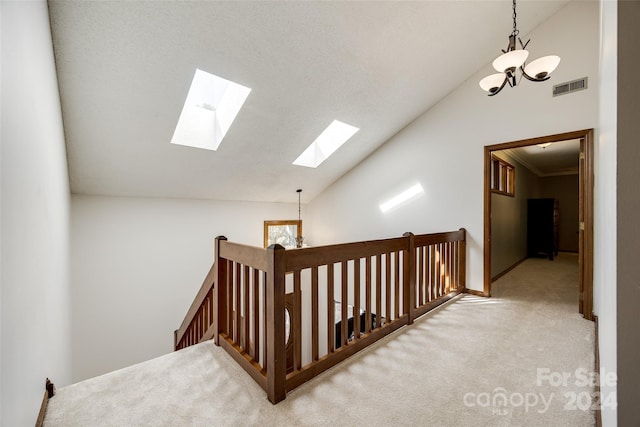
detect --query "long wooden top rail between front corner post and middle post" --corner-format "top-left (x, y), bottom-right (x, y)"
top-left (286, 237), bottom-right (407, 271)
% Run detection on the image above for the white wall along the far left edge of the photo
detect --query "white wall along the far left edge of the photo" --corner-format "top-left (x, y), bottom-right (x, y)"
top-left (0, 1), bottom-right (71, 426)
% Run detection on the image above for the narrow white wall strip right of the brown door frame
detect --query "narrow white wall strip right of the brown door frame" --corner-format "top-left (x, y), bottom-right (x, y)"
top-left (593, 0), bottom-right (618, 426)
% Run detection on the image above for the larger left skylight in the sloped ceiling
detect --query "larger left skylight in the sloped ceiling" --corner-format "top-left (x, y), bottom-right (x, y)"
top-left (171, 69), bottom-right (251, 150)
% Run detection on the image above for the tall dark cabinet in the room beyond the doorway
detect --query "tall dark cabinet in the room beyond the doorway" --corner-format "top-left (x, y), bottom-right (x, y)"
top-left (527, 199), bottom-right (560, 261)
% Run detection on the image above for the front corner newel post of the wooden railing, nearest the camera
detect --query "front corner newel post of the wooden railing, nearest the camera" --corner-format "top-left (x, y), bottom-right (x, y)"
top-left (266, 244), bottom-right (287, 404)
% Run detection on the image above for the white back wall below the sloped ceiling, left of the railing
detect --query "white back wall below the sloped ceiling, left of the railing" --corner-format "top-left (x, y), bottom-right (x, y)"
top-left (71, 195), bottom-right (306, 381)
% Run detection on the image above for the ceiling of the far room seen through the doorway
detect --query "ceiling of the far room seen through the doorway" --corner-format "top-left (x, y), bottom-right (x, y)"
top-left (503, 139), bottom-right (580, 176)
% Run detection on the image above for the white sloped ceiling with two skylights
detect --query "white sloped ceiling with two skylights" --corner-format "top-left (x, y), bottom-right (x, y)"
top-left (49, 0), bottom-right (567, 202)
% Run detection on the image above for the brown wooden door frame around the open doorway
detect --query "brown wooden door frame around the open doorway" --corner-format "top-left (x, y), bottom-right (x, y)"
top-left (483, 129), bottom-right (594, 320)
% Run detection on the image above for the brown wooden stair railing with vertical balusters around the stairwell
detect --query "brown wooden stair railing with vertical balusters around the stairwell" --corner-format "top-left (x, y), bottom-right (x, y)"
top-left (176, 229), bottom-right (466, 403)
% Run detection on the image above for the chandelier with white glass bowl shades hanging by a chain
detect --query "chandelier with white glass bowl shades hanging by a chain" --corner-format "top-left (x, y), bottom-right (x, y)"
top-left (480, 0), bottom-right (560, 96)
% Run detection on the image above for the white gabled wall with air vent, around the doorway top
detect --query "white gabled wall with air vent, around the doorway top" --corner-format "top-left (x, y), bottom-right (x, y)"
top-left (310, 1), bottom-right (599, 290)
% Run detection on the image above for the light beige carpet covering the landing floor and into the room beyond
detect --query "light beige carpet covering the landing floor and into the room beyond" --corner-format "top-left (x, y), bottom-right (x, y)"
top-left (45, 254), bottom-right (595, 426)
